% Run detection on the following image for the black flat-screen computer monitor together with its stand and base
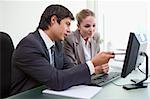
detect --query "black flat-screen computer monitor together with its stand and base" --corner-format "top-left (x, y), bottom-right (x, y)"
top-left (121, 33), bottom-right (148, 90)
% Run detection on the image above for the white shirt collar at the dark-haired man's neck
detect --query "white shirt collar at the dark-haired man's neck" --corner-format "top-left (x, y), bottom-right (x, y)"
top-left (38, 29), bottom-right (55, 49)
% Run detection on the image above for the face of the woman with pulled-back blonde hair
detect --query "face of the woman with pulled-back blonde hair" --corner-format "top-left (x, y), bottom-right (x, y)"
top-left (77, 16), bottom-right (96, 39)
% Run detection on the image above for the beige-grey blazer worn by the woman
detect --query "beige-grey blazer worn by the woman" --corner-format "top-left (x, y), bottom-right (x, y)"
top-left (64, 30), bottom-right (100, 64)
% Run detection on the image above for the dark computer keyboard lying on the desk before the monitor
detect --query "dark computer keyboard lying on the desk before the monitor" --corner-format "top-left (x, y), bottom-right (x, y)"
top-left (91, 72), bottom-right (121, 87)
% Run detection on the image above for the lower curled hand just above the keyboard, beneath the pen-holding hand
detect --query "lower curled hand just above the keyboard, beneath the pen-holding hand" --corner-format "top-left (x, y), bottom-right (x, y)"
top-left (95, 63), bottom-right (109, 74)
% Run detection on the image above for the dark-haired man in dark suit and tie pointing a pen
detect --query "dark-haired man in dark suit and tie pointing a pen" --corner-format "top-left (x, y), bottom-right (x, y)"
top-left (11, 5), bottom-right (114, 95)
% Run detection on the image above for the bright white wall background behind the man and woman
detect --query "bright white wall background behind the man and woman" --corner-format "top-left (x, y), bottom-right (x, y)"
top-left (0, 0), bottom-right (150, 50)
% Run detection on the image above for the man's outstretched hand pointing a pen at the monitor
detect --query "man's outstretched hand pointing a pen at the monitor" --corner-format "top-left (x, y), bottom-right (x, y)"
top-left (91, 52), bottom-right (115, 67)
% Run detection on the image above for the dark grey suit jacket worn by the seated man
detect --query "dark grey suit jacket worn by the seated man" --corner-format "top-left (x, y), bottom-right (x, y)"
top-left (11, 31), bottom-right (91, 94)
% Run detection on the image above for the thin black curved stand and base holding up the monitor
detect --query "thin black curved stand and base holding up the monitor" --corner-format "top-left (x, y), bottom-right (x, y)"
top-left (123, 52), bottom-right (148, 90)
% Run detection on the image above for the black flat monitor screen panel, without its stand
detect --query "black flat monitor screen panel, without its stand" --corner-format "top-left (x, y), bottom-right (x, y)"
top-left (121, 33), bottom-right (146, 78)
